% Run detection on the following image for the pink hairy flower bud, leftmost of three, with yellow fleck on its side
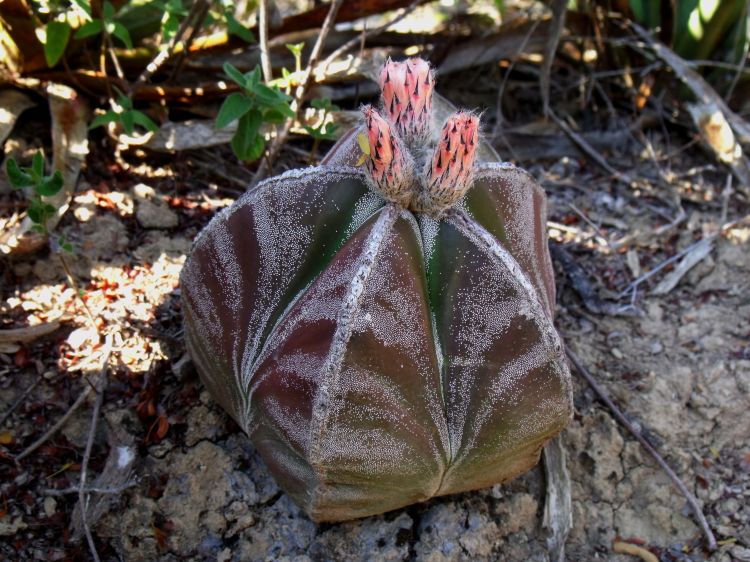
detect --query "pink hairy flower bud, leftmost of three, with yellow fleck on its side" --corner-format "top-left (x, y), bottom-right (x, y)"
top-left (362, 105), bottom-right (414, 206)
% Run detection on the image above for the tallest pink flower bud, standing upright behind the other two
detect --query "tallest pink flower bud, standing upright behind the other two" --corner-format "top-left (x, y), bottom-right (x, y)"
top-left (380, 59), bottom-right (435, 143)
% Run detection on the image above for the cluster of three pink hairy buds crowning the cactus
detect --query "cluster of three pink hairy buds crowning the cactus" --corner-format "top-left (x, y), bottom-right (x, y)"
top-left (362, 58), bottom-right (479, 216)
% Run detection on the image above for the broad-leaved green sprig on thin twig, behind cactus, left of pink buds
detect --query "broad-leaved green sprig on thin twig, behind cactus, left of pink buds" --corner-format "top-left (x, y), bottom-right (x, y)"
top-left (216, 63), bottom-right (294, 161)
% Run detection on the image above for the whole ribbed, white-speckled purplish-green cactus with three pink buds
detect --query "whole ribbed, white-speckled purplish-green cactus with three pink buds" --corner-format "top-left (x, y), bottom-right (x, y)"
top-left (182, 59), bottom-right (572, 521)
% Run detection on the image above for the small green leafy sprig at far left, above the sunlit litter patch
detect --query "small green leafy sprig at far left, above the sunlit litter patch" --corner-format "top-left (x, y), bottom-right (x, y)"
top-left (5, 150), bottom-right (73, 252)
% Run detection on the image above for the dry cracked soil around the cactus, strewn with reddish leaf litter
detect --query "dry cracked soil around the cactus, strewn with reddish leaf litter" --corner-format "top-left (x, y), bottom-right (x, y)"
top-left (0, 74), bottom-right (750, 562)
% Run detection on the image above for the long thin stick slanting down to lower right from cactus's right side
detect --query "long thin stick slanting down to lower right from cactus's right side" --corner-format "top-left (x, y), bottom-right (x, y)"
top-left (565, 345), bottom-right (718, 552)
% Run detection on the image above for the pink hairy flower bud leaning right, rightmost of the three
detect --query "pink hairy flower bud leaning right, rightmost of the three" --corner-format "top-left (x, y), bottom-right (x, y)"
top-left (423, 111), bottom-right (479, 211)
